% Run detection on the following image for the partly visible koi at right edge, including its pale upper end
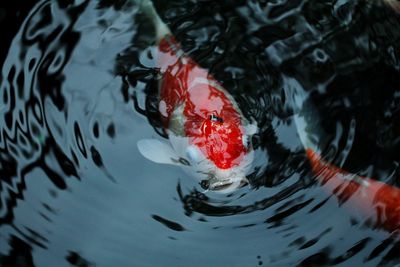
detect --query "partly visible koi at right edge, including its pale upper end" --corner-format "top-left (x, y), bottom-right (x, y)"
top-left (289, 78), bottom-right (400, 232)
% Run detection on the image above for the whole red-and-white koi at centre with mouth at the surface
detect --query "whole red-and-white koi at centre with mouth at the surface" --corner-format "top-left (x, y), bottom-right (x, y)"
top-left (137, 1), bottom-right (257, 193)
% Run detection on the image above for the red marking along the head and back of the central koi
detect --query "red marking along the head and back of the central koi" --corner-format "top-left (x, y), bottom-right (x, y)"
top-left (158, 36), bottom-right (247, 169)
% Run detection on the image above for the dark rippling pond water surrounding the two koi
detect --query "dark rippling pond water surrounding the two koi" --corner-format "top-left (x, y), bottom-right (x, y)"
top-left (0, 0), bottom-right (400, 266)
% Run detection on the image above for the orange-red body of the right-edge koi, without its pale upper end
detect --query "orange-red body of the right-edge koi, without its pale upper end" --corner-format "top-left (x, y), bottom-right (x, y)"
top-left (306, 149), bottom-right (400, 232)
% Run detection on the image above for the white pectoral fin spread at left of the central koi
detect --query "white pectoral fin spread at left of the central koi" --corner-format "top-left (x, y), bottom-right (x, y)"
top-left (137, 139), bottom-right (181, 165)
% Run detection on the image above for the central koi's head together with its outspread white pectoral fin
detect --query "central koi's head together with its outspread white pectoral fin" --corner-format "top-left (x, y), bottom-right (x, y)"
top-left (138, 103), bottom-right (257, 193)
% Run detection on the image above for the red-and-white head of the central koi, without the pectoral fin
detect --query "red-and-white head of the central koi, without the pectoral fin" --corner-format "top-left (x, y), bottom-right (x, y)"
top-left (185, 113), bottom-right (256, 193)
